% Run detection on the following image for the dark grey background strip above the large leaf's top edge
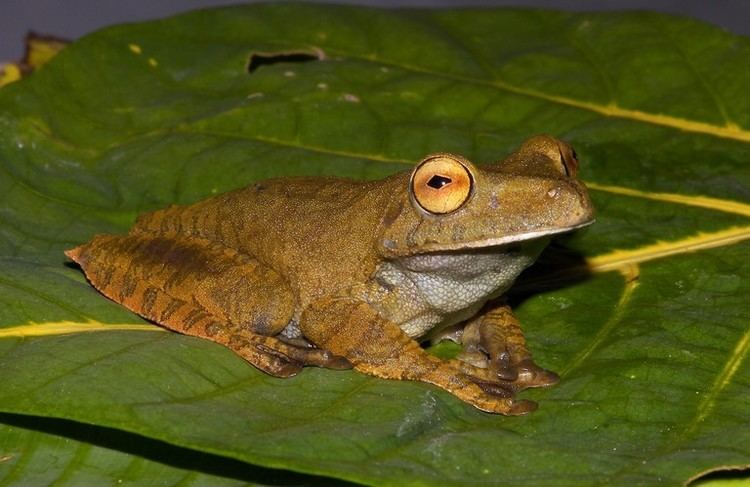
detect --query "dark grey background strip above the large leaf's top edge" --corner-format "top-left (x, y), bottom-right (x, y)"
top-left (0, 0), bottom-right (750, 62)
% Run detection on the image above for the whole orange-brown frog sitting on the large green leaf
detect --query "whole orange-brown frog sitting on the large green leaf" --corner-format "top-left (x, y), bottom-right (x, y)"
top-left (66, 135), bottom-right (594, 415)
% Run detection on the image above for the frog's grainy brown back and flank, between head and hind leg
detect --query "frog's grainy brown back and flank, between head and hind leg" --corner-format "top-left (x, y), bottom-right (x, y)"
top-left (131, 173), bottom-right (400, 296)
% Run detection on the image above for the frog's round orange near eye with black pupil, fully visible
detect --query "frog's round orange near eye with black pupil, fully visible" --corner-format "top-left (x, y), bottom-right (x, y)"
top-left (411, 154), bottom-right (473, 215)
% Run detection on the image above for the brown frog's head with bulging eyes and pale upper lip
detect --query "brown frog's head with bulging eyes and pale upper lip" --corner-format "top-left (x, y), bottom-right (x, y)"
top-left (378, 136), bottom-right (594, 258)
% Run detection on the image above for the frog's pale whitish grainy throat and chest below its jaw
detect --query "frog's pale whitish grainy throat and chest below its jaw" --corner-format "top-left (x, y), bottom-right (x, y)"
top-left (368, 245), bottom-right (543, 338)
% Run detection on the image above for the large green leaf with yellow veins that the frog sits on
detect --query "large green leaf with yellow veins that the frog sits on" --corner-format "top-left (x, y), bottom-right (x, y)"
top-left (0, 4), bottom-right (750, 485)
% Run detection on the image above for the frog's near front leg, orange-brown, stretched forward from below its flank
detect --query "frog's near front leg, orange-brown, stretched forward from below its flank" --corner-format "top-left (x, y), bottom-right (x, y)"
top-left (300, 297), bottom-right (536, 415)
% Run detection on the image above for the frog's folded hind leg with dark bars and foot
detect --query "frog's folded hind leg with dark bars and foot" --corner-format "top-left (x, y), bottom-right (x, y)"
top-left (66, 234), bottom-right (348, 377)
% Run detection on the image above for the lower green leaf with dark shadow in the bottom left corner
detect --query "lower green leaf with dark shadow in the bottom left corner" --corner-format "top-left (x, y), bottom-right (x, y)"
top-left (0, 414), bottom-right (340, 486)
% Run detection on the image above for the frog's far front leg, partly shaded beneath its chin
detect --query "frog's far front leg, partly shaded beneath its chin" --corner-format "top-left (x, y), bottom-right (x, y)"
top-left (462, 305), bottom-right (560, 390)
